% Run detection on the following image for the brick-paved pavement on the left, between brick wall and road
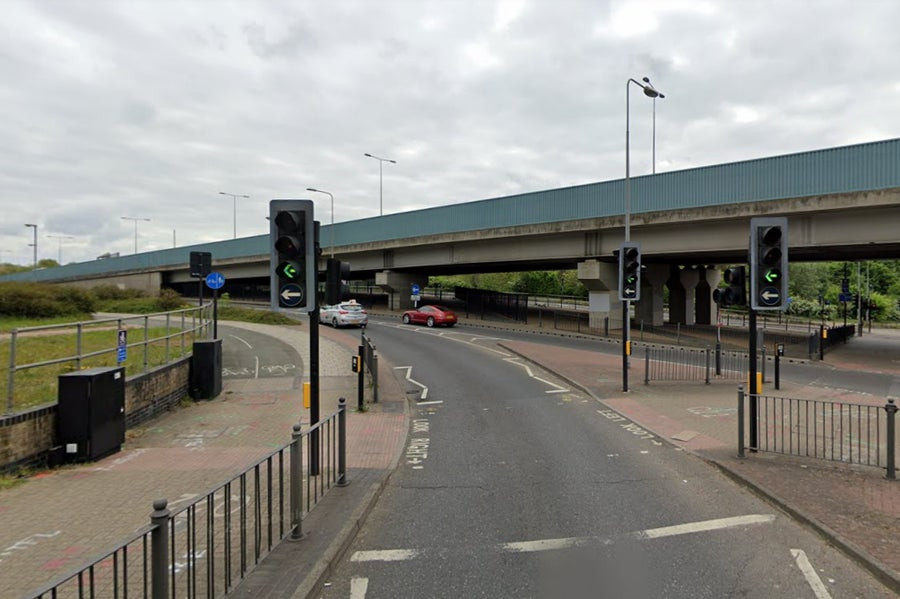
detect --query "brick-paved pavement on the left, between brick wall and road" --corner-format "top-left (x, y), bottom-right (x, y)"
top-left (0, 323), bottom-right (407, 598)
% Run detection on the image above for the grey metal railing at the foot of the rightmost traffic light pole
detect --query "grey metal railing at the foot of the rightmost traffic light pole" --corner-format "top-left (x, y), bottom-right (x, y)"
top-left (738, 386), bottom-right (897, 479)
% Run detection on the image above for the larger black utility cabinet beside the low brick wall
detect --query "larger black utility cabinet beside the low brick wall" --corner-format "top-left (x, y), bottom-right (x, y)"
top-left (56, 367), bottom-right (125, 461)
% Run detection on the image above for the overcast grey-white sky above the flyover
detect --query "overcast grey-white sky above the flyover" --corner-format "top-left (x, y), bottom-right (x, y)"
top-left (0, 0), bottom-right (900, 264)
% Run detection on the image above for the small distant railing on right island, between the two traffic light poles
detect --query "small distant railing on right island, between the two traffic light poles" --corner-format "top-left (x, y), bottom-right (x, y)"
top-left (644, 345), bottom-right (766, 385)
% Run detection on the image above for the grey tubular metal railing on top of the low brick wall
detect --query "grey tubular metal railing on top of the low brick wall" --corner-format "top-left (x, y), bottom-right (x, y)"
top-left (6, 304), bottom-right (212, 413)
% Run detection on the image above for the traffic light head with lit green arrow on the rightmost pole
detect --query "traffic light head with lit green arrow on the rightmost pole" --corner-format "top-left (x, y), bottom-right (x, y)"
top-left (750, 217), bottom-right (788, 310)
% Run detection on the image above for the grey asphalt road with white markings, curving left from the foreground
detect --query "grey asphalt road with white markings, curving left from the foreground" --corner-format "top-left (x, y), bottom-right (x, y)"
top-left (321, 319), bottom-right (891, 599)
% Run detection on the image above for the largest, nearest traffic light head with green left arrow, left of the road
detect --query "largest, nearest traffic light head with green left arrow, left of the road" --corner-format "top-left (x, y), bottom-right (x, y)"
top-left (269, 200), bottom-right (317, 312)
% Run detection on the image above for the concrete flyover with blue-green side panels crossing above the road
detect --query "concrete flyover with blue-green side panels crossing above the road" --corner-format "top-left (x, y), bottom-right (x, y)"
top-left (7, 139), bottom-right (900, 326)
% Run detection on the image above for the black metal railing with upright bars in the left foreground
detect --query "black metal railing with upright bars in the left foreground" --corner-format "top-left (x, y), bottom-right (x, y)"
top-left (27, 398), bottom-right (347, 599)
